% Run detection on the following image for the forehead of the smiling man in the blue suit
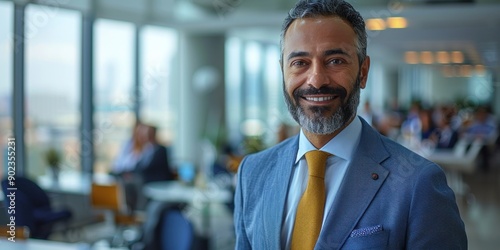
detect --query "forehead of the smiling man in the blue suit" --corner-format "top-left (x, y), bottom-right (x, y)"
top-left (283, 16), bottom-right (356, 54)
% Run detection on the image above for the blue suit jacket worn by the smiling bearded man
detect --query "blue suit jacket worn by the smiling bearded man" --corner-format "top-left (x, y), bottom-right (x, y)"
top-left (234, 119), bottom-right (467, 250)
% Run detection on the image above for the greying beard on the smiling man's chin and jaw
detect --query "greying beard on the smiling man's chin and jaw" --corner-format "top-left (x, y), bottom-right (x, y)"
top-left (283, 76), bottom-right (361, 135)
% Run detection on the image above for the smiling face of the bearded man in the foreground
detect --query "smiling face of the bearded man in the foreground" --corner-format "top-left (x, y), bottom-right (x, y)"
top-left (282, 17), bottom-right (369, 134)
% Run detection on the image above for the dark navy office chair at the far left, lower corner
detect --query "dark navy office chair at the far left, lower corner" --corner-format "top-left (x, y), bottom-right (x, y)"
top-left (2, 176), bottom-right (72, 239)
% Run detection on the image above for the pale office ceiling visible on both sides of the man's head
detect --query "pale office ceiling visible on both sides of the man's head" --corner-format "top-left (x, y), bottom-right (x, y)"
top-left (22, 0), bottom-right (500, 74)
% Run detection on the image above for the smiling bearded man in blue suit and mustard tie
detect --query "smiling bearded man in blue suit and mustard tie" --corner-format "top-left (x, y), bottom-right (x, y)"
top-left (234, 0), bottom-right (467, 250)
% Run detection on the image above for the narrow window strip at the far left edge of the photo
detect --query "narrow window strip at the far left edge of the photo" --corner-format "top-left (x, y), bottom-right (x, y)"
top-left (0, 2), bottom-right (14, 178)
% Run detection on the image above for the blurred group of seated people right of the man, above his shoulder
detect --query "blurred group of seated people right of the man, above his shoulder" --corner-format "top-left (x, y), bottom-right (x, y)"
top-left (372, 102), bottom-right (500, 170)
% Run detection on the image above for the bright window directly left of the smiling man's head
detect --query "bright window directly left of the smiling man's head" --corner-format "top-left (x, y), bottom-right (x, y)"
top-left (226, 37), bottom-right (293, 148)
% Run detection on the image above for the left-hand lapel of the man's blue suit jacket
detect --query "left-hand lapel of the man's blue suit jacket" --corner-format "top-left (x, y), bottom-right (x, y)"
top-left (261, 136), bottom-right (299, 249)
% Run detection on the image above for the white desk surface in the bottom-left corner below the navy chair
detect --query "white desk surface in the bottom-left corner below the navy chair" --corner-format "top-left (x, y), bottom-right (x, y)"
top-left (0, 239), bottom-right (90, 250)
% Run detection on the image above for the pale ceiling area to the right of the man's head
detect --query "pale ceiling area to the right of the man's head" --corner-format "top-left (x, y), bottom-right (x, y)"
top-left (364, 4), bottom-right (500, 71)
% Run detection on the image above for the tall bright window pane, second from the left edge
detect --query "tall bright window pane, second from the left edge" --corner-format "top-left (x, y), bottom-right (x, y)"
top-left (25, 4), bottom-right (81, 176)
